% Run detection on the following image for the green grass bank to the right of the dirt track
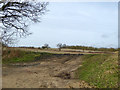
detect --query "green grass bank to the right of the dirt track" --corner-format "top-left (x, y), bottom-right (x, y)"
top-left (76, 54), bottom-right (118, 88)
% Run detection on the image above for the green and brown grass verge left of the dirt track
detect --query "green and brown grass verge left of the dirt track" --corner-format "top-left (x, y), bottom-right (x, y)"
top-left (2, 49), bottom-right (51, 64)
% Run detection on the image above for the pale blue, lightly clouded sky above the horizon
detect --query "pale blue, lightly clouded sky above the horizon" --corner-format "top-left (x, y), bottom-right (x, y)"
top-left (16, 2), bottom-right (118, 48)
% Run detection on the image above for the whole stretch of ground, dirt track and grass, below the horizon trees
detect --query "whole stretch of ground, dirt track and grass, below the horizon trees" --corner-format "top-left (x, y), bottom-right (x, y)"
top-left (2, 48), bottom-right (118, 88)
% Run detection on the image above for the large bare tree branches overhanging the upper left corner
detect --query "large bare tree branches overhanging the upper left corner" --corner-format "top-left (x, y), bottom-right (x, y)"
top-left (0, 0), bottom-right (48, 44)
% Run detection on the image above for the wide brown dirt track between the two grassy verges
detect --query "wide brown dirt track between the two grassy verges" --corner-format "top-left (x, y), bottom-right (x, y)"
top-left (3, 55), bottom-right (91, 88)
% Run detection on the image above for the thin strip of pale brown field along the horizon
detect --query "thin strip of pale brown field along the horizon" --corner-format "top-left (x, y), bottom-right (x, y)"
top-left (9, 47), bottom-right (114, 54)
